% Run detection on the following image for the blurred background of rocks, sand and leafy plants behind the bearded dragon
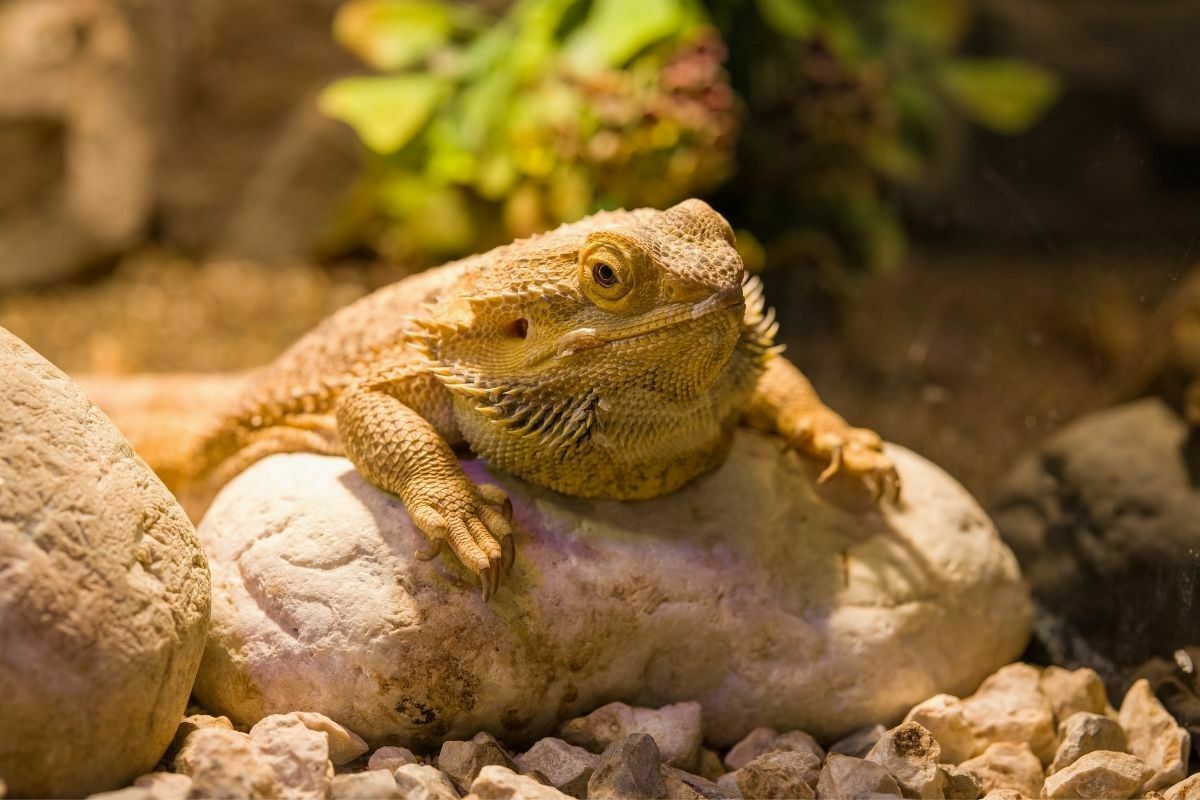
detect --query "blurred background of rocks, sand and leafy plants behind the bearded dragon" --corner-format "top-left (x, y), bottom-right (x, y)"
top-left (0, 0), bottom-right (1200, 724)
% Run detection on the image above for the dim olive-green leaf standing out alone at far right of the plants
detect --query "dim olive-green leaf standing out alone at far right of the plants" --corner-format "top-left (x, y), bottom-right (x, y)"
top-left (938, 59), bottom-right (1060, 133)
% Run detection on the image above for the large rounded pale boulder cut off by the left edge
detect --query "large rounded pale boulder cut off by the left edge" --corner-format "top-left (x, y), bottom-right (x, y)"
top-left (0, 329), bottom-right (209, 796)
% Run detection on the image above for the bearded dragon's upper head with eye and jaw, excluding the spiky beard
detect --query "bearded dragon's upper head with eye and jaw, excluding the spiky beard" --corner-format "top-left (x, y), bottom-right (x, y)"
top-left (431, 200), bottom-right (745, 374)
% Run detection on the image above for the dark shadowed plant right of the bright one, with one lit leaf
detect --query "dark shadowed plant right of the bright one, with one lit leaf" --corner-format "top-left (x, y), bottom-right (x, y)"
top-left (710, 0), bottom-right (1058, 278)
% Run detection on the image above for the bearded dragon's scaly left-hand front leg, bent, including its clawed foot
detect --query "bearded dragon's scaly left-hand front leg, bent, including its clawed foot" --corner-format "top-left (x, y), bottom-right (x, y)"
top-left (337, 374), bottom-right (514, 601)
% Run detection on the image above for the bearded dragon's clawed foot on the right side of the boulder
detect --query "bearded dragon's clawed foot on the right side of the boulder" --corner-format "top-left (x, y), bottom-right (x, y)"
top-left (793, 417), bottom-right (901, 503)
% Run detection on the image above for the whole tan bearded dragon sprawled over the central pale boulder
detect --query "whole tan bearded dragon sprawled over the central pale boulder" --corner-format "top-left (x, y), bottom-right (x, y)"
top-left (194, 200), bottom-right (900, 601)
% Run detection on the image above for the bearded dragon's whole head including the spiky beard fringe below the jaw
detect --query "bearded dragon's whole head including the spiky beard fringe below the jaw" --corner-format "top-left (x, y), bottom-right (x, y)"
top-left (419, 200), bottom-right (770, 448)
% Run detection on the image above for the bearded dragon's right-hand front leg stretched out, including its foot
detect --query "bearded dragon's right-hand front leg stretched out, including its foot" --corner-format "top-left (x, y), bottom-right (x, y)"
top-left (744, 356), bottom-right (900, 500)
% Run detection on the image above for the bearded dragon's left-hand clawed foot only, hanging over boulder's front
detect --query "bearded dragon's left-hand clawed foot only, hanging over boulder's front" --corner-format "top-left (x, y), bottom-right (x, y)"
top-left (408, 479), bottom-right (516, 602)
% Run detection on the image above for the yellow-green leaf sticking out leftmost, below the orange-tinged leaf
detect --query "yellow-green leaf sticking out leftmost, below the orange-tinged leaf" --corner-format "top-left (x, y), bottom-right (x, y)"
top-left (317, 74), bottom-right (445, 154)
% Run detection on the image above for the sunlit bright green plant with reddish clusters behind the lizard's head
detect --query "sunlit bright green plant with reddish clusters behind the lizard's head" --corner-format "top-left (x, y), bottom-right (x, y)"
top-left (319, 0), bottom-right (737, 264)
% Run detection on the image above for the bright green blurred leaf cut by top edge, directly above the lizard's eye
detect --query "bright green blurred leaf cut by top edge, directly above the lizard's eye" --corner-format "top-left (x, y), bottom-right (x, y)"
top-left (563, 0), bottom-right (692, 72)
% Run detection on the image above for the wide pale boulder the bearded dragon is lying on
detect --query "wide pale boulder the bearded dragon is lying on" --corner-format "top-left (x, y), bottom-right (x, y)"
top-left (196, 432), bottom-right (1031, 747)
